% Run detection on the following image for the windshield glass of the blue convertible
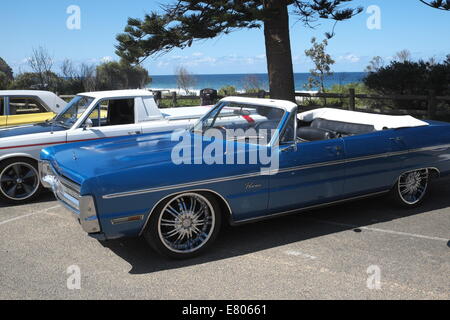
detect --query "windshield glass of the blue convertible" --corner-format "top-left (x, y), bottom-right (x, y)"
top-left (192, 102), bottom-right (285, 144)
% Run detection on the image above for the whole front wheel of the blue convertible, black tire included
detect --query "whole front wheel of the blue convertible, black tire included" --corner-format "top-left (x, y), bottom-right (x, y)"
top-left (143, 192), bottom-right (222, 260)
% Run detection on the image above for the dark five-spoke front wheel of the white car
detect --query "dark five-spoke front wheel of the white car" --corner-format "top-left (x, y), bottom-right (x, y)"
top-left (0, 162), bottom-right (39, 201)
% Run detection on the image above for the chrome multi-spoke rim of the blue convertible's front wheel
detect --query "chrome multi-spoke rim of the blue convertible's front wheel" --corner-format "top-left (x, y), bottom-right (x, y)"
top-left (158, 193), bottom-right (216, 254)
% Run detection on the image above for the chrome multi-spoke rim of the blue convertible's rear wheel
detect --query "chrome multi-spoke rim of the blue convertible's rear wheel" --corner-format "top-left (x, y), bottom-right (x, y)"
top-left (398, 169), bottom-right (429, 205)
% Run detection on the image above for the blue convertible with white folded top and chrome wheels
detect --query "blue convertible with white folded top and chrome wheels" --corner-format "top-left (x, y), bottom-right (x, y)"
top-left (40, 97), bottom-right (450, 258)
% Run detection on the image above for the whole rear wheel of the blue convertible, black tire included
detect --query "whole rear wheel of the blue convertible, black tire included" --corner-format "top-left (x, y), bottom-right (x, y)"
top-left (391, 169), bottom-right (431, 208)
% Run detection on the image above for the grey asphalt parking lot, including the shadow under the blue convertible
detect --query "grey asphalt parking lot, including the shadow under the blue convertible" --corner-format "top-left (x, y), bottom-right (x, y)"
top-left (0, 180), bottom-right (450, 299)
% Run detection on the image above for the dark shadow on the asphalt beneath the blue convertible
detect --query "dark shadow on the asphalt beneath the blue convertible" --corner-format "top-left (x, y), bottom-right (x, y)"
top-left (102, 179), bottom-right (450, 274)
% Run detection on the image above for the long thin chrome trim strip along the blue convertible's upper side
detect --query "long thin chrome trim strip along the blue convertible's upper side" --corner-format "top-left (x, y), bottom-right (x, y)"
top-left (103, 144), bottom-right (450, 199)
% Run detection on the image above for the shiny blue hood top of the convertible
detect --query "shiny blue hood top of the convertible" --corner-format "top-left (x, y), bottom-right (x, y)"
top-left (41, 133), bottom-right (179, 184)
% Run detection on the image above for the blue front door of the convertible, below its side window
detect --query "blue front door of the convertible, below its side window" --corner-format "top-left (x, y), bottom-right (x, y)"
top-left (269, 139), bottom-right (345, 213)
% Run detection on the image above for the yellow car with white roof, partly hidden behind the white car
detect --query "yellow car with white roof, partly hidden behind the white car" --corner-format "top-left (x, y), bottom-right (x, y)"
top-left (0, 90), bottom-right (67, 127)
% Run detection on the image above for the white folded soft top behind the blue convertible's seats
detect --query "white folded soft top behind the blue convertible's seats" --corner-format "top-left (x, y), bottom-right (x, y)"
top-left (298, 108), bottom-right (429, 131)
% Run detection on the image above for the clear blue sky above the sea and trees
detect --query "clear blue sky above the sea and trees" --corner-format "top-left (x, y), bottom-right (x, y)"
top-left (0, 0), bottom-right (450, 75)
